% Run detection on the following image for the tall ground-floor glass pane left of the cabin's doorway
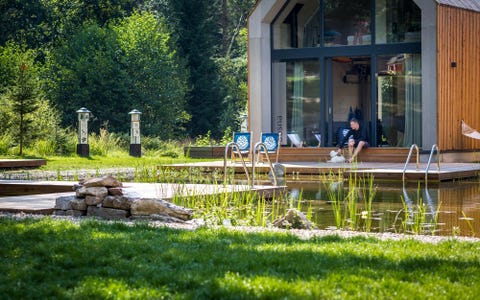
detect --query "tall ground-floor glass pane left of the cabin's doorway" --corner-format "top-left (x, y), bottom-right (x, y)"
top-left (272, 60), bottom-right (320, 145)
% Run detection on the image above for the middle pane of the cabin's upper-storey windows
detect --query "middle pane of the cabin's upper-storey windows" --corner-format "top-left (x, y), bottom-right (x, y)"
top-left (324, 0), bottom-right (372, 46)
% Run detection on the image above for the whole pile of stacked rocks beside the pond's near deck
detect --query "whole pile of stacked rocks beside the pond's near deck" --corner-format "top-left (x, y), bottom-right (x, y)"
top-left (55, 176), bottom-right (193, 222)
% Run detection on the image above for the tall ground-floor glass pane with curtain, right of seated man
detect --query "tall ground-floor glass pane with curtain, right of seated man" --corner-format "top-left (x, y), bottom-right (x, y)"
top-left (377, 54), bottom-right (422, 147)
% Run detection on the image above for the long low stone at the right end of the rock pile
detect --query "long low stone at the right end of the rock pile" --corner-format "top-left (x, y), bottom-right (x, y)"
top-left (130, 199), bottom-right (193, 220)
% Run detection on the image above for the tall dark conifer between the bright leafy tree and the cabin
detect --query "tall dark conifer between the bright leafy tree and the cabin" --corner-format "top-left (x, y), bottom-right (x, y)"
top-left (164, 0), bottom-right (224, 136)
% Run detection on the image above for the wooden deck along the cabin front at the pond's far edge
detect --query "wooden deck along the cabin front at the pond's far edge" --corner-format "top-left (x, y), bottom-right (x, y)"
top-left (179, 147), bottom-right (480, 181)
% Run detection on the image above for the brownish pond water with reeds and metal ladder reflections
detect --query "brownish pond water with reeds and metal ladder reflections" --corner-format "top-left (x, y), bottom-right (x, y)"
top-left (287, 181), bottom-right (480, 237)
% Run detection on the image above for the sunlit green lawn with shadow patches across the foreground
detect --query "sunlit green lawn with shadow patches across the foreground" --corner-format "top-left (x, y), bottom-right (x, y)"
top-left (0, 217), bottom-right (480, 299)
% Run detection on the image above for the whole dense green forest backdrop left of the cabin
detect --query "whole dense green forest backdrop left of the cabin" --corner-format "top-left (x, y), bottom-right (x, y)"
top-left (0, 0), bottom-right (255, 155)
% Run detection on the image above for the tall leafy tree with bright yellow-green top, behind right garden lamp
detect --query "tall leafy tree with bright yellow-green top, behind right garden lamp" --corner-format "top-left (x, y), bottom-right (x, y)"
top-left (114, 12), bottom-right (189, 139)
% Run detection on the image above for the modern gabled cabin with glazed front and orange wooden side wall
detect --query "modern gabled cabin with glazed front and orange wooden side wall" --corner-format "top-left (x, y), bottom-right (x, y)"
top-left (248, 0), bottom-right (480, 159)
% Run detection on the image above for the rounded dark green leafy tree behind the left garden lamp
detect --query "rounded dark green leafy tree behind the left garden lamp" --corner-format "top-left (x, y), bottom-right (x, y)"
top-left (48, 23), bottom-right (131, 132)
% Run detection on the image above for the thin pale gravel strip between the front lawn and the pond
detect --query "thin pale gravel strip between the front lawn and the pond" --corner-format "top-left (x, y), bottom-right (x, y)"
top-left (0, 212), bottom-right (480, 244)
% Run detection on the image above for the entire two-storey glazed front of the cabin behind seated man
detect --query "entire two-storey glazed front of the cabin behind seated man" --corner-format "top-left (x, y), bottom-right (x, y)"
top-left (271, 0), bottom-right (422, 147)
